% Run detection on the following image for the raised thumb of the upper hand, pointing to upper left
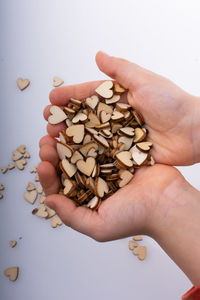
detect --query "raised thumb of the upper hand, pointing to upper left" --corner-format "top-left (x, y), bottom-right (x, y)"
top-left (96, 51), bottom-right (149, 89)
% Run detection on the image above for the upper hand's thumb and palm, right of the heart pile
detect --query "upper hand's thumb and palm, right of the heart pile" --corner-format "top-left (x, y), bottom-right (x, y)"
top-left (96, 52), bottom-right (200, 165)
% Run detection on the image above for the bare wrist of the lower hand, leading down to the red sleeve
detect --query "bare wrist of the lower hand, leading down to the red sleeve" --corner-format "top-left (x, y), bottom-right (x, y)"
top-left (152, 173), bottom-right (200, 285)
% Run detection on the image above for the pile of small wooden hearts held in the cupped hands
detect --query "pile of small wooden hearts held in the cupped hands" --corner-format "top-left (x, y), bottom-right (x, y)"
top-left (48, 81), bottom-right (154, 209)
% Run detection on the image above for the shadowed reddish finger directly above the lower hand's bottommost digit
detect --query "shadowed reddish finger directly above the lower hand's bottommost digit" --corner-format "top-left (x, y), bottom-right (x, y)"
top-left (38, 161), bottom-right (60, 195)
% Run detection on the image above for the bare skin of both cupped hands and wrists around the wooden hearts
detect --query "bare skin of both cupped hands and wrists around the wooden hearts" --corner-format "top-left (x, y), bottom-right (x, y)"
top-left (38, 52), bottom-right (200, 285)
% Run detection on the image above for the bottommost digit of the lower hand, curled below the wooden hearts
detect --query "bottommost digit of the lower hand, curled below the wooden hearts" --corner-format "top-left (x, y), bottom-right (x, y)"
top-left (45, 195), bottom-right (103, 238)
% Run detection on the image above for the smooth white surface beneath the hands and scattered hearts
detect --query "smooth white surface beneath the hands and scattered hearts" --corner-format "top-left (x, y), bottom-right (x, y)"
top-left (0, 0), bottom-right (200, 300)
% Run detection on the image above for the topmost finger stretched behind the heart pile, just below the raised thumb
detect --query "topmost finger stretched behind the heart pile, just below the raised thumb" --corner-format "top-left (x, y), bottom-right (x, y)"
top-left (49, 81), bottom-right (102, 106)
